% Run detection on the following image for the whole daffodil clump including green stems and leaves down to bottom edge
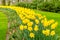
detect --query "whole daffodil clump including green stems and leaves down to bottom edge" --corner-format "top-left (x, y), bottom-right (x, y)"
top-left (2, 6), bottom-right (58, 40)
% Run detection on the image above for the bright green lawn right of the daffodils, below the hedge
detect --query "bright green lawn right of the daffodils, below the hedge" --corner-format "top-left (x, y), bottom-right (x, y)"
top-left (35, 10), bottom-right (60, 35)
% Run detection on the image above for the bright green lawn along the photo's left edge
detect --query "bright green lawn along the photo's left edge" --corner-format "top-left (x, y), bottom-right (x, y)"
top-left (0, 12), bottom-right (8, 40)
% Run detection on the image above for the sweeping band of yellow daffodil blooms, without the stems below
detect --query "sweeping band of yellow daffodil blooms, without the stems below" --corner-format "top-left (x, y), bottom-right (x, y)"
top-left (0, 6), bottom-right (58, 38)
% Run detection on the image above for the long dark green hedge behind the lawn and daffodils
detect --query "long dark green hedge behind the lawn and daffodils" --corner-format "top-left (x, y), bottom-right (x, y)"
top-left (16, 0), bottom-right (60, 12)
